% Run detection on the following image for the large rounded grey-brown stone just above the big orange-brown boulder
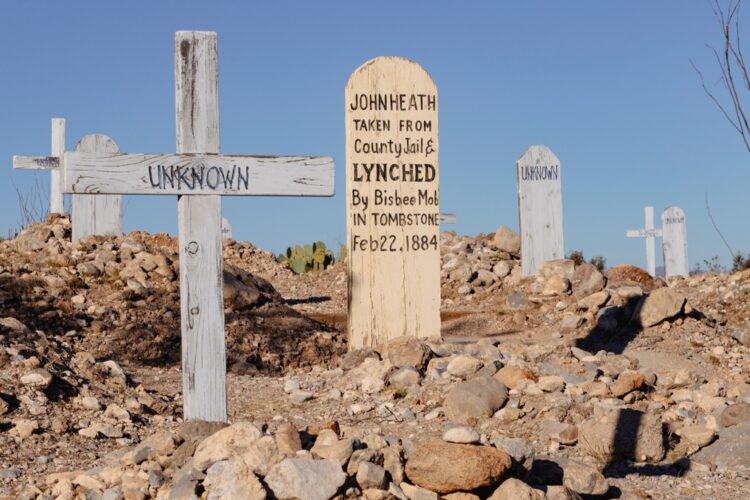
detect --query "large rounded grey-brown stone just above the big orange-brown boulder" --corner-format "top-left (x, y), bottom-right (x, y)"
top-left (443, 377), bottom-right (508, 425)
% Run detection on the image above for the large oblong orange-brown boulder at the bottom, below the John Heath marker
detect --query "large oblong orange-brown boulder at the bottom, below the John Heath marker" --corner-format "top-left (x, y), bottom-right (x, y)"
top-left (406, 441), bottom-right (511, 494)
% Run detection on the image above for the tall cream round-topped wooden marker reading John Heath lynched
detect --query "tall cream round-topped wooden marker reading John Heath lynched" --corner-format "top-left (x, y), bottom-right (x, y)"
top-left (345, 57), bottom-right (440, 349)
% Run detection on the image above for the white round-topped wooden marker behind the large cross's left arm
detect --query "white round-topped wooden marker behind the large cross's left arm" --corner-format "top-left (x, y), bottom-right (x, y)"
top-left (72, 134), bottom-right (122, 241)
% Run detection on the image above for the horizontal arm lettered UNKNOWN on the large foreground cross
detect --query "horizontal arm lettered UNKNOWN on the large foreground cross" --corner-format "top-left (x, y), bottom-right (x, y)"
top-left (63, 153), bottom-right (334, 196)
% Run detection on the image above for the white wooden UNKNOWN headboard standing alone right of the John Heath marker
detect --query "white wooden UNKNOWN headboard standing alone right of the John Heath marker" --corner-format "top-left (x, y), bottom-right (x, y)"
top-left (516, 146), bottom-right (565, 276)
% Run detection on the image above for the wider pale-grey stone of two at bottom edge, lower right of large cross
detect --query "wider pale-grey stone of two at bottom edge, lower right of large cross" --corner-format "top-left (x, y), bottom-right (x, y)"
top-left (265, 458), bottom-right (346, 500)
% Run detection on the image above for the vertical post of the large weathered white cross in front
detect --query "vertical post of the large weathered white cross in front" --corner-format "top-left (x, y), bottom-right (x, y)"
top-left (174, 31), bottom-right (227, 421)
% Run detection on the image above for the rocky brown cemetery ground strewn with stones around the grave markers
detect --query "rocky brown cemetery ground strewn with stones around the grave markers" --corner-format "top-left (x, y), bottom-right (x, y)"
top-left (0, 216), bottom-right (750, 499)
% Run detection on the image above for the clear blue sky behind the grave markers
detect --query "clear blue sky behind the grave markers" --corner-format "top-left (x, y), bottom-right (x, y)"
top-left (0, 0), bottom-right (750, 267)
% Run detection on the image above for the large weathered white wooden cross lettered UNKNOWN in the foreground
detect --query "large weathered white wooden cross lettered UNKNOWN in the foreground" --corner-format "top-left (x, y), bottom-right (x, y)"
top-left (63, 31), bottom-right (334, 421)
